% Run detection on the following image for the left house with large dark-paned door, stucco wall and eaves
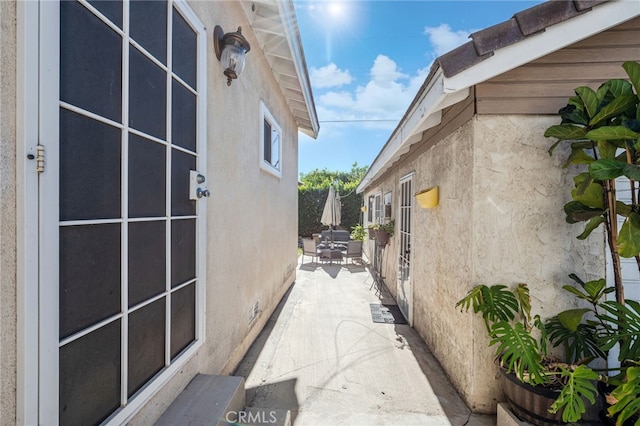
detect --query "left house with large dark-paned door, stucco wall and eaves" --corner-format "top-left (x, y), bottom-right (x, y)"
top-left (0, 0), bottom-right (318, 425)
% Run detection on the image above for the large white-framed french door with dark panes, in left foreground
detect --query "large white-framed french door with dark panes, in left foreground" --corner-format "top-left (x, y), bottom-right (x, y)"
top-left (38, 0), bottom-right (206, 424)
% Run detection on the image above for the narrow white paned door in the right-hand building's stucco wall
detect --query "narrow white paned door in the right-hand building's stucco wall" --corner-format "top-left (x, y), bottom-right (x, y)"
top-left (397, 175), bottom-right (413, 324)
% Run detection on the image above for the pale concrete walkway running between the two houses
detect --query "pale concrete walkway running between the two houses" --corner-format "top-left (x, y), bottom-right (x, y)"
top-left (234, 256), bottom-right (496, 426)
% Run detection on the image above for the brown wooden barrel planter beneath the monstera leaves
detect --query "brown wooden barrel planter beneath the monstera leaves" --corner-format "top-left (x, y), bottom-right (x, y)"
top-left (500, 368), bottom-right (602, 426)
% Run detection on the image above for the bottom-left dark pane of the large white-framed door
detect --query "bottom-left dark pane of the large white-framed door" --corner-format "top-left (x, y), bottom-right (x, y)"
top-left (60, 320), bottom-right (121, 425)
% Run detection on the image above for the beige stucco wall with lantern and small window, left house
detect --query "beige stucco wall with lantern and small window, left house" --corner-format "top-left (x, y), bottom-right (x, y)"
top-left (132, 1), bottom-right (298, 424)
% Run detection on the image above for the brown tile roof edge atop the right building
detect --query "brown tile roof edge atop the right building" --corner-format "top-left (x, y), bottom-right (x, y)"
top-left (436, 0), bottom-right (608, 77)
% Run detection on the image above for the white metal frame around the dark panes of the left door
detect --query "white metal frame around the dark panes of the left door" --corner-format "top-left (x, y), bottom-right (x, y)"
top-left (28, 0), bottom-right (207, 424)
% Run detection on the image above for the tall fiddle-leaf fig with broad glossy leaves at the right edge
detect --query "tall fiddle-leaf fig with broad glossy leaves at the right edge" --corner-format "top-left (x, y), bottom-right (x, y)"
top-left (545, 62), bottom-right (640, 425)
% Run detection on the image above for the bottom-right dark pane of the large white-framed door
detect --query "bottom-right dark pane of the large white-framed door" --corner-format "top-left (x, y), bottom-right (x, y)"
top-left (171, 283), bottom-right (196, 360)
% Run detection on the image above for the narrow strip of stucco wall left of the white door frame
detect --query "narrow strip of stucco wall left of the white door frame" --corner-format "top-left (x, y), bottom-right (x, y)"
top-left (0, 1), bottom-right (17, 425)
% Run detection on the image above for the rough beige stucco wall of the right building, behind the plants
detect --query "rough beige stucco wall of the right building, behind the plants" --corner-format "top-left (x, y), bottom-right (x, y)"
top-left (370, 116), bottom-right (605, 412)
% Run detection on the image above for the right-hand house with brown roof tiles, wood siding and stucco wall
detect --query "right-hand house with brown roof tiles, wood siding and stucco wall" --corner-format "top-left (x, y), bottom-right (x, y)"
top-left (357, 0), bottom-right (640, 412)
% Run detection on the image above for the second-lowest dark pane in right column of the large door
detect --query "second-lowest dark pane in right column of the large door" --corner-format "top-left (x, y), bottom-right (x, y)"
top-left (171, 219), bottom-right (196, 287)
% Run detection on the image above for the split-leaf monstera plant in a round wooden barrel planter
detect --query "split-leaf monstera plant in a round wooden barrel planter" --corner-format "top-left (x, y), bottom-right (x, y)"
top-left (456, 275), bottom-right (610, 425)
